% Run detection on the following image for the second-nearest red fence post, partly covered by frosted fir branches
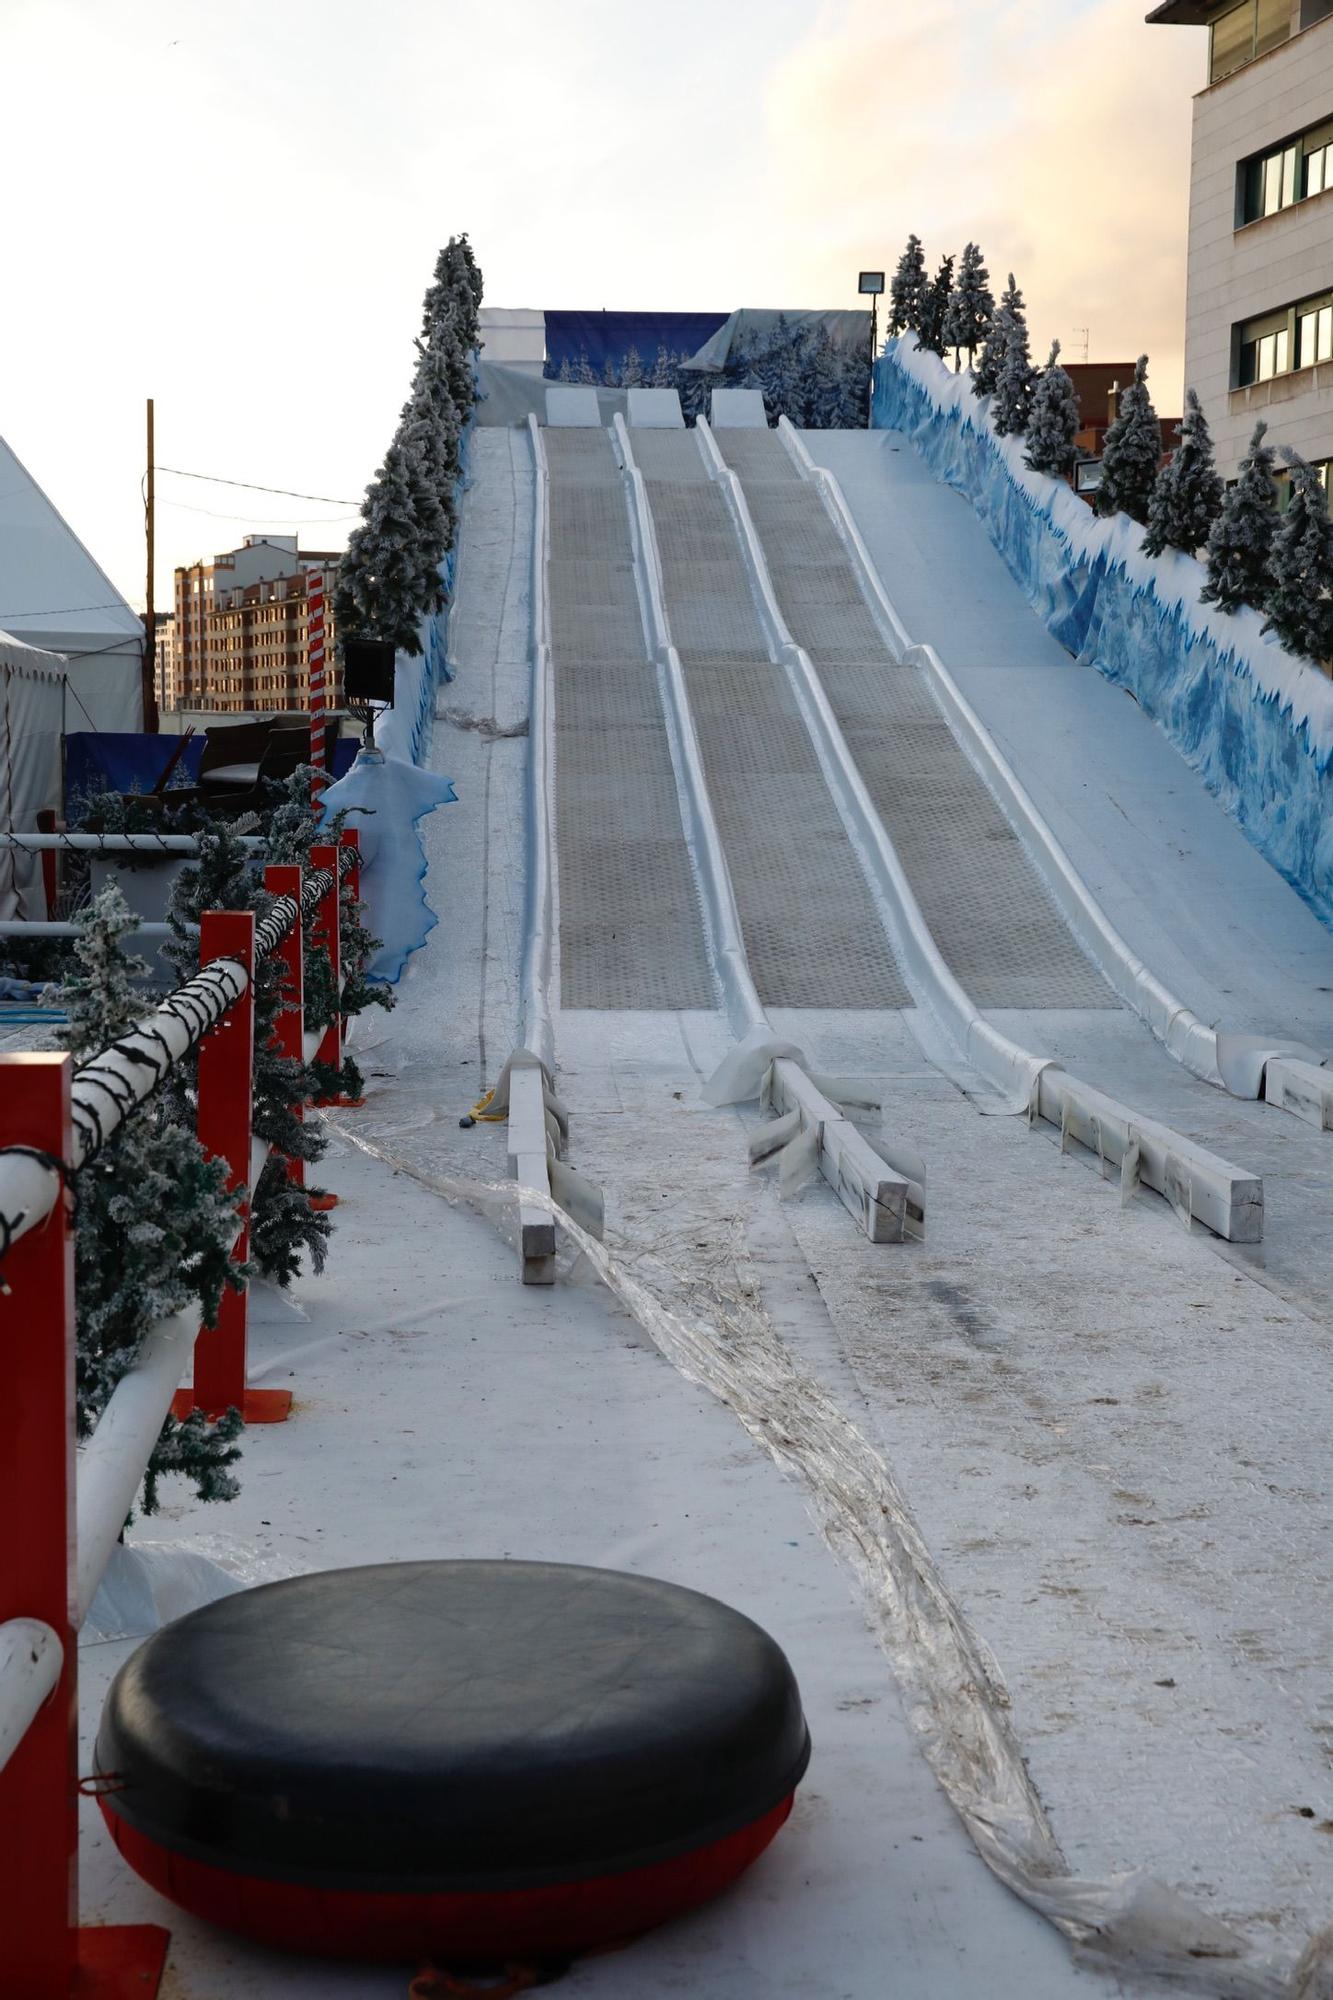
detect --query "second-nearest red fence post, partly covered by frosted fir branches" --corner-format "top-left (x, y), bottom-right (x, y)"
top-left (172, 910), bottom-right (292, 1424)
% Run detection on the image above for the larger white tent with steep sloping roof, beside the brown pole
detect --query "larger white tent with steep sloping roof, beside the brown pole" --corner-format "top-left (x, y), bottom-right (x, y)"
top-left (0, 438), bottom-right (144, 730)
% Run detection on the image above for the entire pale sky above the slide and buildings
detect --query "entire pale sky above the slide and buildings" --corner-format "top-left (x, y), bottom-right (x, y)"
top-left (0, 0), bottom-right (1205, 610)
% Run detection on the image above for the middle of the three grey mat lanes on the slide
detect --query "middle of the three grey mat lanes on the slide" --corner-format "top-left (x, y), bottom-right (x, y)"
top-left (634, 432), bottom-right (911, 1008)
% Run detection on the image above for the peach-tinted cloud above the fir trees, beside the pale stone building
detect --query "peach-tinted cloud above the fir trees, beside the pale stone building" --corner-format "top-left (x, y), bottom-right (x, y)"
top-left (767, 0), bottom-right (1203, 414)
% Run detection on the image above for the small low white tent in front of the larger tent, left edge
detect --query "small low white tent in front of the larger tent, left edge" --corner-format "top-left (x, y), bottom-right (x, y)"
top-left (0, 632), bottom-right (64, 918)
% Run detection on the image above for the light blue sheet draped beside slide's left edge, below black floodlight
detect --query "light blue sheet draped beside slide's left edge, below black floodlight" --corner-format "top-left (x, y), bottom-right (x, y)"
top-left (324, 750), bottom-right (458, 984)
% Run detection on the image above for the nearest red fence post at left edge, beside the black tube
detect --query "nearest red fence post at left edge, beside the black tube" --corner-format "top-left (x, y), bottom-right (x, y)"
top-left (0, 1054), bottom-right (168, 2000)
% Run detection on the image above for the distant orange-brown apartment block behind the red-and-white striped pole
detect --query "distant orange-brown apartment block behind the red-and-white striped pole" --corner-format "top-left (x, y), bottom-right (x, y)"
top-left (168, 534), bottom-right (342, 714)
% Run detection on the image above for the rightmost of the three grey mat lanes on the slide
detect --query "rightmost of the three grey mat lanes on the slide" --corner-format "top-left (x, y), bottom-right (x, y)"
top-left (717, 430), bottom-right (1119, 1008)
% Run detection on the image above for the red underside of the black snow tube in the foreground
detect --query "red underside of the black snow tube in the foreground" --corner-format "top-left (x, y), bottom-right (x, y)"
top-left (102, 1794), bottom-right (795, 1966)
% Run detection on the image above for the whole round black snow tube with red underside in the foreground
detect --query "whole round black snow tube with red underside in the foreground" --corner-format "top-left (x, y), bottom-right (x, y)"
top-left (94, 1562), bottom-right (811, 1968)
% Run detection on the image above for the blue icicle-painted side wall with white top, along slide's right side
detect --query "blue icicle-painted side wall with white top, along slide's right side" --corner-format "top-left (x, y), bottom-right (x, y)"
top-left (871, 338), bottom-right (1333, 926)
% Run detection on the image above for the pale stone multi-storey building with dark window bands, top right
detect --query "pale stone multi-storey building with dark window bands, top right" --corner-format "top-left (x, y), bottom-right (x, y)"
top-left (1147, 0), bottom-right (1333, 484)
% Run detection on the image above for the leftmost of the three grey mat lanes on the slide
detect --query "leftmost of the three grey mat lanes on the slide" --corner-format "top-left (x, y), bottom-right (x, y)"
top-left (544, 430), bottom-right (717, 1010)
